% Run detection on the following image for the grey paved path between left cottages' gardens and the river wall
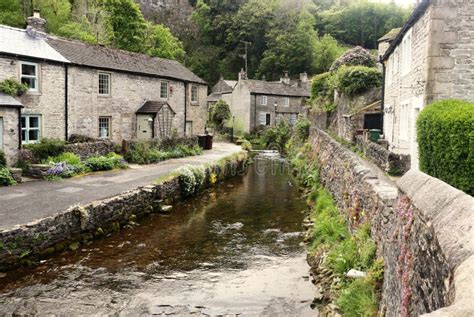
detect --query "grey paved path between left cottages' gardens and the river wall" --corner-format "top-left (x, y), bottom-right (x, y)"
top-left (0, 143), bottom-right (241, 230)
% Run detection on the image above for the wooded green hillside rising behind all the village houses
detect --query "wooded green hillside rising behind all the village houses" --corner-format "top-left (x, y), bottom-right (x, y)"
top-left (0, 0), bottom-right (411, 84)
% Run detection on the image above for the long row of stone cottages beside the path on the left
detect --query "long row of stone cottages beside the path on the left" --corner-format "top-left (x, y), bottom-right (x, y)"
top-left (0, 12), bottom-right (207, 162)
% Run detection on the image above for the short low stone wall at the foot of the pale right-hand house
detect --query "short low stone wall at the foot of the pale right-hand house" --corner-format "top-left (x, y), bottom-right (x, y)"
top-left (356, 135), bottom-right (410, 175)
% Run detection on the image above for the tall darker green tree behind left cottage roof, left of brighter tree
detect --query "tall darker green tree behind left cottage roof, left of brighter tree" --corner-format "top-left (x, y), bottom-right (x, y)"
top-left (103, 0), bottom-right (147, 52)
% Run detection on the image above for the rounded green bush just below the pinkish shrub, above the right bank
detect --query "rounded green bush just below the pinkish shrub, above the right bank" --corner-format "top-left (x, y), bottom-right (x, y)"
top-left (335, 66), bottom-right (382, 96)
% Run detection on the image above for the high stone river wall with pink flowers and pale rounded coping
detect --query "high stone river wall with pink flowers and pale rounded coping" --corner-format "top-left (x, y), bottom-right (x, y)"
top-left (310, 128), bottom-right (474, 316)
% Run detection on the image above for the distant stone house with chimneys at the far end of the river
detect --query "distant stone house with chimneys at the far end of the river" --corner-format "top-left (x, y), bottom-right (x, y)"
top-left (207, 71), bottom-right (310, 132)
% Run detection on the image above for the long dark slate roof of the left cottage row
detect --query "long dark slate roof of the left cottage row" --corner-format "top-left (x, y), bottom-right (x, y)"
top-left (47, 37), bottom-right (207, 85)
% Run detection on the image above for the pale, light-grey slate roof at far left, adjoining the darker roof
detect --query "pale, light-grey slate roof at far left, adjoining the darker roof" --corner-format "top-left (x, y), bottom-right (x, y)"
top-left (0, 25), bottom-right (68, 63)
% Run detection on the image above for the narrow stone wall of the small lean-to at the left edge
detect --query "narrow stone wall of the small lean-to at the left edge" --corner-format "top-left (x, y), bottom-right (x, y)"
top-left (0, 107), bottom-right (20, 165)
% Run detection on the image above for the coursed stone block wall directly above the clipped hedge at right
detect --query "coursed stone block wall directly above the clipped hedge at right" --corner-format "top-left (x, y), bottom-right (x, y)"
top-left (427, 0), bottom-right (474, 104)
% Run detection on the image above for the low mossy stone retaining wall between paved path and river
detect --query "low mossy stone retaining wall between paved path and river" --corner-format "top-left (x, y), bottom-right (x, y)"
top-left (0, 152), bottom-right (247, 271)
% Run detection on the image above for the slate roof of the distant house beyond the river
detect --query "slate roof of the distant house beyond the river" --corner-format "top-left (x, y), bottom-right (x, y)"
top-left (243, 80), bottom-right (310, 97)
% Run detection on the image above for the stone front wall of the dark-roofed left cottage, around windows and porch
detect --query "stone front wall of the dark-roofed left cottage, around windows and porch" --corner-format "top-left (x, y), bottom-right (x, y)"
top-left (69, 67), bottom-right (189, 142)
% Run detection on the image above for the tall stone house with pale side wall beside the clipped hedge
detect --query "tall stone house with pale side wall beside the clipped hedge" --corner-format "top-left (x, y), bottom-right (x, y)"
top-left (379, 0), bottom-right (474, 169)
